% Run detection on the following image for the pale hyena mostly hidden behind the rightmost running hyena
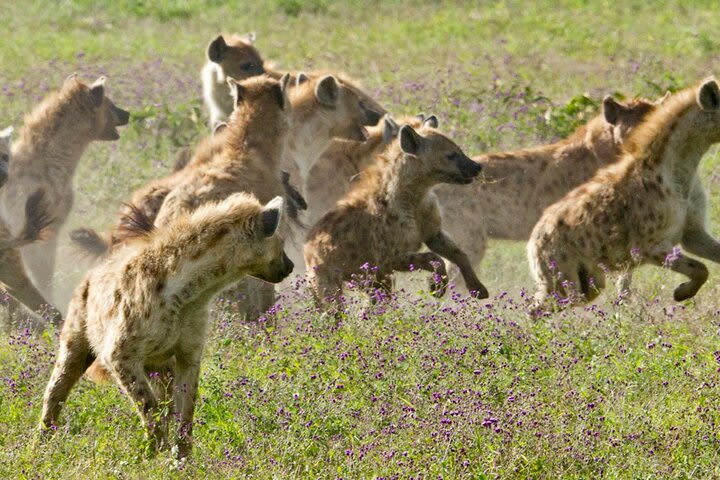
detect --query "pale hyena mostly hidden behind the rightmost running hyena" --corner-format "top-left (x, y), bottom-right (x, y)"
top-left (435, 96), bottom-right (663, 267)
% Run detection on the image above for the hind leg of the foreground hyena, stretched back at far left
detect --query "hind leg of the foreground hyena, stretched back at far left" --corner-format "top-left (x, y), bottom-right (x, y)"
top-left (40, 329), bottom-right (95, 431)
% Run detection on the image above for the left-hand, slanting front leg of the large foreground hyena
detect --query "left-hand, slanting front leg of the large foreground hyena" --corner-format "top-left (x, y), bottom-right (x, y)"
top-left (105, 356), bottom-right (167, 451)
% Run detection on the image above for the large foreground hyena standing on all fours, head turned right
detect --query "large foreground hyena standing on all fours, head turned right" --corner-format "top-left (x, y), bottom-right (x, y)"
top-left (40, 193), bottom-right (293, 457)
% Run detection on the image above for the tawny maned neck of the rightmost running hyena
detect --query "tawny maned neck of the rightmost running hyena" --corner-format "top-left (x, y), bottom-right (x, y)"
top-left (624, 88), bottom-right (714, 188)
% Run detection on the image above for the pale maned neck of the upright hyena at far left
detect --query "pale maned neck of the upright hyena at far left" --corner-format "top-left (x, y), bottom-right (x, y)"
top-left (10, 83), bottom-right (94, 179)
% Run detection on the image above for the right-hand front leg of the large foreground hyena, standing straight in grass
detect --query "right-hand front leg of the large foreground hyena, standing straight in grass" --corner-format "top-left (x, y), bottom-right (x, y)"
top-left (173, 348), bottom-right (202, 458)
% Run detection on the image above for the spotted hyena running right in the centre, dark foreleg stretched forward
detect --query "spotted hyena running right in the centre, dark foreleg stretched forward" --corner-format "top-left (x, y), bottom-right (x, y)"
top-left (305, 119), bottom-right (488, 304)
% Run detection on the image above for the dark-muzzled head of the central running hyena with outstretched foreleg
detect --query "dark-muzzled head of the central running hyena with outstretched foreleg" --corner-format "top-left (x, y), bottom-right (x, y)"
top-left (398, 115), bottom-right (481, 184)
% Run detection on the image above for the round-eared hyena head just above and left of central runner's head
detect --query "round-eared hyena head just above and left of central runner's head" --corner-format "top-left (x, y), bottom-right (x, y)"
top-left (290, 73), bottom-right (382, 141)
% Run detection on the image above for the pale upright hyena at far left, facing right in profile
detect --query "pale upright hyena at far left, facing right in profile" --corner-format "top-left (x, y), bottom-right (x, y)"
top-left (0, 76), bottom-right (129, 300)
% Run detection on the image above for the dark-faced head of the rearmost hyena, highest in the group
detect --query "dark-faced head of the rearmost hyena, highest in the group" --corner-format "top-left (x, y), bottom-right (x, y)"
top-left (207, 32), bottom-right (265, 81)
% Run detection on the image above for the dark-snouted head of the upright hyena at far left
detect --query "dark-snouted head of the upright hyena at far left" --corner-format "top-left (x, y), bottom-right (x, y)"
top-left (61, 75), bottom-right (130, 140)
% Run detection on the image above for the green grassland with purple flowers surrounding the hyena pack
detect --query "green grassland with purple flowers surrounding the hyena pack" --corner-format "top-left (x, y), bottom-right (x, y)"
top-left (0, 0), bottom-right (720, 479)
